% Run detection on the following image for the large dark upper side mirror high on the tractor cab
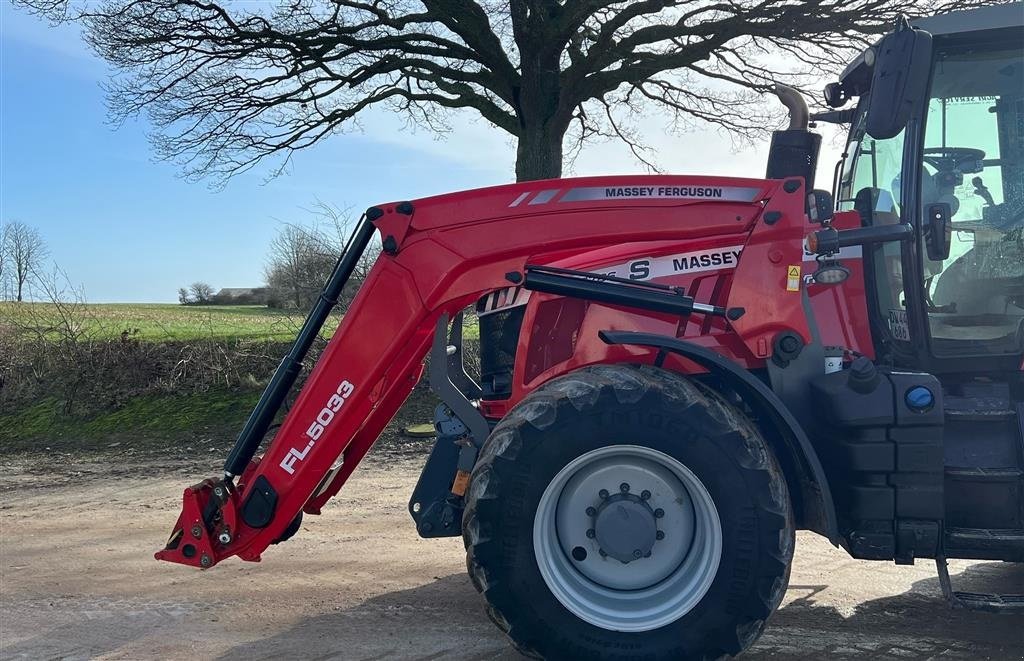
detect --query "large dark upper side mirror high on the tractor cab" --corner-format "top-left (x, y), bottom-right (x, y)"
top-left (864, 18), bottom-right (932, 140)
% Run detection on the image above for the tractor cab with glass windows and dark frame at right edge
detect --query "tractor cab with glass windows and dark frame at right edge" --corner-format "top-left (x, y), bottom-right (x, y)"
top-left (825, 3), bottom-right (1024, 373)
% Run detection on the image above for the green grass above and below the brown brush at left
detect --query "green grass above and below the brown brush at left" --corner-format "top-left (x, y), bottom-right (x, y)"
top-left (0, 303), bottom-right (471, 453)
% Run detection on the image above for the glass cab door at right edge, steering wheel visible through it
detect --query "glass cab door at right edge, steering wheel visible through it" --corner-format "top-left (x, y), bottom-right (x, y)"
top-left (920, 43), bottom-right (1024, 365)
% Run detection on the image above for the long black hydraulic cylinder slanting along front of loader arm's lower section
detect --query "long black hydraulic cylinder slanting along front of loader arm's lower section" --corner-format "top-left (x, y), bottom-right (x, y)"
top-left (224, 217), bottom-right (375, 478)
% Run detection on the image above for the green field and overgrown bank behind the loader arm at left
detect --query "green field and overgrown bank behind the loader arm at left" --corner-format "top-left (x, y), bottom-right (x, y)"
top-left (0, 303), bottom-right (464, 454)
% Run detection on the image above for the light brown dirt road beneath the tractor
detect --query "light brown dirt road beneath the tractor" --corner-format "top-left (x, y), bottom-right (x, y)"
top-left (0, 456), bottom-right (1024, 661)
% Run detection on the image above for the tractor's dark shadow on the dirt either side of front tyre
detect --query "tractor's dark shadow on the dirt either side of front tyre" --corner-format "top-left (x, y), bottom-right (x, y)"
top-left (221, 561), bottom-right (1024, 661)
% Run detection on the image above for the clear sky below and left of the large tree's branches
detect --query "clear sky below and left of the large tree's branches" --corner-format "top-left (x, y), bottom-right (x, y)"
top-left (0, 0), bottom-right (830, 302)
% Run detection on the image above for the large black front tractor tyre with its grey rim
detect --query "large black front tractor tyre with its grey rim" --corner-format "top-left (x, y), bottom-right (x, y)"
top-left (463, 365), bottom-right (795, 660)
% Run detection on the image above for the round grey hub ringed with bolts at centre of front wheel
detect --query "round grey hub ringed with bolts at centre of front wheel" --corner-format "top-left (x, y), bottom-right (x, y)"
top-left (593, 493), bottom-right (657, 563)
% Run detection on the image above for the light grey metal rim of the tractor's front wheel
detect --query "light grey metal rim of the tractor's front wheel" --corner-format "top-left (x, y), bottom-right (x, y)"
top-left (534, 445), bottom-right (722, 631)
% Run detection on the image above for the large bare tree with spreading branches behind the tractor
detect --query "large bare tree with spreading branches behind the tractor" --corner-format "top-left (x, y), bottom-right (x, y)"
top-left (9, 0), bottom-right (995, 180)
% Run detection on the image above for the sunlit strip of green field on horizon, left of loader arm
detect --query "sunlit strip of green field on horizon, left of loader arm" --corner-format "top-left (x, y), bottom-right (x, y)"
top-left (0, 303), bottom-right (340, 342)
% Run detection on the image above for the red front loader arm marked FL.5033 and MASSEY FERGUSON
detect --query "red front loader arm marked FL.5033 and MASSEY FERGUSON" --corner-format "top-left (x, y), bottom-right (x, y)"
top-left (157, 176), bottom-right (807, 568)
